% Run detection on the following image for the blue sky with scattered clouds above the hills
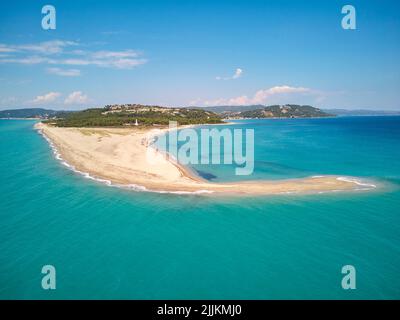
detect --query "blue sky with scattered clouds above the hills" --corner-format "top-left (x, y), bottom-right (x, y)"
top-left (0, 0), bottom-right (400, 110)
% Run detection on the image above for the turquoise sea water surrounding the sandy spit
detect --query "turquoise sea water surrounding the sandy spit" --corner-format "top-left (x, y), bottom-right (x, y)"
top-left (0, 117), bottom-right (400, 299)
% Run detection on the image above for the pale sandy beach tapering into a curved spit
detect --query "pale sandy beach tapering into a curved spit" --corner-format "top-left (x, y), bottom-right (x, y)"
top-left (35, 123), bottom-right (372, 195)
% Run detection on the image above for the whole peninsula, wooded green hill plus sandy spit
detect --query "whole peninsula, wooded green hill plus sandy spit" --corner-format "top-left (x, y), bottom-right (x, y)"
top-left (36, 105), bottom-right (376, 195)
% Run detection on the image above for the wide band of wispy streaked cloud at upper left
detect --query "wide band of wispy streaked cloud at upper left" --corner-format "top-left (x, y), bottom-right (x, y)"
top-left (0, 40), bottom-right (147, 69)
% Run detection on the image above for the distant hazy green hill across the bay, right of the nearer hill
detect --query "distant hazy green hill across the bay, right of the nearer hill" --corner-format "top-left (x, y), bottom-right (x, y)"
top-left (212, 104), bottom-right (333, 119)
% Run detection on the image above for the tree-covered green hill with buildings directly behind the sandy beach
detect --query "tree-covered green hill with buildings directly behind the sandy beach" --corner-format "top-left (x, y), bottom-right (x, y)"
top-left (48, 104), bottom-right (223, 127)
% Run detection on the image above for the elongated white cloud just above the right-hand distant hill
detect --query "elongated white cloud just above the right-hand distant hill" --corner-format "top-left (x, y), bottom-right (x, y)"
top-left (204, 85), bottom-right (313, 106)
